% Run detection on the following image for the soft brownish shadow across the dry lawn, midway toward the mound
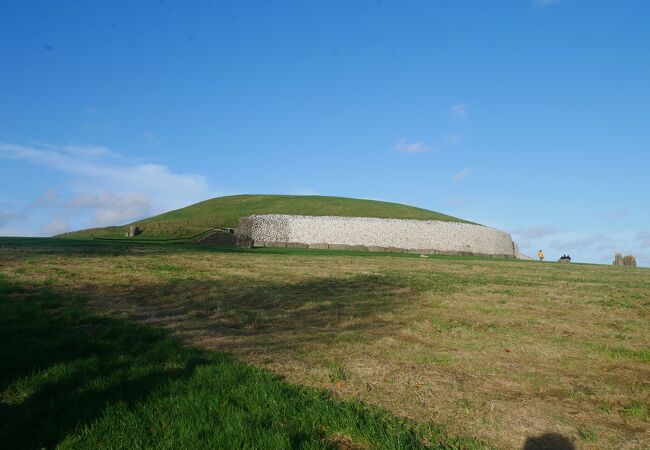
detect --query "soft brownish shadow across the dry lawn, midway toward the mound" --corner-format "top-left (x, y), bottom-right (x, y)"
top-left (81, 274), bottom-right (457, 353)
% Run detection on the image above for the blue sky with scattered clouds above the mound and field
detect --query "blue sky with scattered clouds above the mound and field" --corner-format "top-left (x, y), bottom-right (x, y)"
top-left (0, 0), bottom-right (650, 265)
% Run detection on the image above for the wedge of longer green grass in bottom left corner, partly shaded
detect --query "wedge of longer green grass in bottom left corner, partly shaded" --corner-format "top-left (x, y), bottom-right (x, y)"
top-left (0, 279), bottom-right (482, 449)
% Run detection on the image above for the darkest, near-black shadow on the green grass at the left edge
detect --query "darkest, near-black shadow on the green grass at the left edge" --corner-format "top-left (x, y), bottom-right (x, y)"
top-left (0, 280), bottom-right (204, 448)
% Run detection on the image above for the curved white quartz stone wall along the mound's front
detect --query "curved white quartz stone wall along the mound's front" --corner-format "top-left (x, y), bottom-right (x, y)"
top-left (237, 214), bottom-right (516, 258)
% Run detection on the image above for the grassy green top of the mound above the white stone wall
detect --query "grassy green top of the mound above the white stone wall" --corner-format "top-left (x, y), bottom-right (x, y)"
top-left (60, 195), bottom-right (470, 238)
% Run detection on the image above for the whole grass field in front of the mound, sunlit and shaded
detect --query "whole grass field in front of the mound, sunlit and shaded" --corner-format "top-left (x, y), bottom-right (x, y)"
top-left (0, 239), bottom-right (650, 448)
